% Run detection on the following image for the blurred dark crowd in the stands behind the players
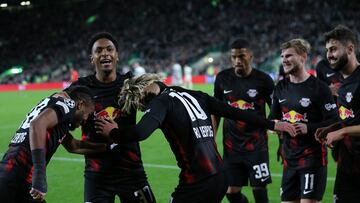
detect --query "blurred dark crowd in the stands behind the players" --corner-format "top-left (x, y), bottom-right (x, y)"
top-left (0, 0), bottom-right (360, 83)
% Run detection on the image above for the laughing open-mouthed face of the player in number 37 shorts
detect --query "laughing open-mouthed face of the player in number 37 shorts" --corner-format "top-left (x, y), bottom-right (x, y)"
top-left (91, 38), bottom-right (118, 75)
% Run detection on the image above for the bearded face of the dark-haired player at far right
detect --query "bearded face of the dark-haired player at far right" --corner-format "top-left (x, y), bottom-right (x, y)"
top-left (326, 39), bottom-right (349, 71)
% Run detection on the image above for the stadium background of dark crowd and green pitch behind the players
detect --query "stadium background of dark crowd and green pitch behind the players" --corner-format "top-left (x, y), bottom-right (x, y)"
top-left (0, 0), bottom-right (360, 203)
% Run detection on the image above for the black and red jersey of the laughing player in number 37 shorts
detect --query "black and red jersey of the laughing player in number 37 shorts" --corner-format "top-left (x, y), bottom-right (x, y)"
top-left (72, 74), bottom-right (146, 185)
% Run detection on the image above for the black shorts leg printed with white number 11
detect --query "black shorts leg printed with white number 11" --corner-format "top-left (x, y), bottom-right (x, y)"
top-left (300, 166), bottom-right (327, 201)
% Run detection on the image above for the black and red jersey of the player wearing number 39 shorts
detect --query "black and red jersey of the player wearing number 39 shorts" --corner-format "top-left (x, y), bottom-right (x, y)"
top-left (214, 68), bottom-right (274, 159)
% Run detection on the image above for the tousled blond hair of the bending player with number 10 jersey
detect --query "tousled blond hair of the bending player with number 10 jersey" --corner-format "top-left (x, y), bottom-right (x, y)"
top-left (118, 73), bottom-right (163, 114)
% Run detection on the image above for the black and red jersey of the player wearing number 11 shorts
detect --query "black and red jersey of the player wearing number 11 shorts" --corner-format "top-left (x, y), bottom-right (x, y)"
top-left (270, 76), bottom-right (338, 169)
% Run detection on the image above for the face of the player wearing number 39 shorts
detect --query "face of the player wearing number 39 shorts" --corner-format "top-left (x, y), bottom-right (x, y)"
top-left (230, 48), bottom-right (252, 77)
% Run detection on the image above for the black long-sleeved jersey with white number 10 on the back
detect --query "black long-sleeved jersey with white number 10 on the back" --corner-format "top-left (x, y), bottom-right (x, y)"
top-left (111, 87), bottom-right (274, 184)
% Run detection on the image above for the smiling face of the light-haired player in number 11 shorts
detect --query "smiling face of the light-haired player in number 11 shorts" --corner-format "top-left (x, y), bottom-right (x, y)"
top-left (281, 47), bottom-right (306, 74)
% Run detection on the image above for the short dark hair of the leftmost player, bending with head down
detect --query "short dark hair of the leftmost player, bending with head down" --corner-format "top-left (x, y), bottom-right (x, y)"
top-left (64, 85), bottom-right (94, 104)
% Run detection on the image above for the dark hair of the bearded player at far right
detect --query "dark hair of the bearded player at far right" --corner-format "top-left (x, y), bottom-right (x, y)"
top-left (324, 25), bottom-right (358, 47)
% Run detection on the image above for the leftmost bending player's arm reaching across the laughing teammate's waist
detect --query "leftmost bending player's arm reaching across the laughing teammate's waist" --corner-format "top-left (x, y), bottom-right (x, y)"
top-left (61, 133), bottom-right (107, 155)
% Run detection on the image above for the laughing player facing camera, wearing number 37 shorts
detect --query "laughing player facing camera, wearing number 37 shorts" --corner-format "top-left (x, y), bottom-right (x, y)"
top-left (68, 32), bottom-right (156, 203)
